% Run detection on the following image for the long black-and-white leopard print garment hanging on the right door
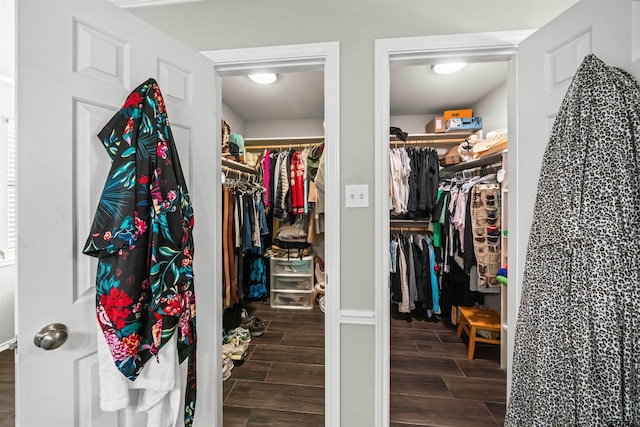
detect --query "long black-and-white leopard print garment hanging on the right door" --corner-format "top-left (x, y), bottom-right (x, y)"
top-left (505, 55), bottom-right (640, 427)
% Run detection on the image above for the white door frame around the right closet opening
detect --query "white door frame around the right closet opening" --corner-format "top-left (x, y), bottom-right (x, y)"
top-left (374, 30), bottom-right (533, 426)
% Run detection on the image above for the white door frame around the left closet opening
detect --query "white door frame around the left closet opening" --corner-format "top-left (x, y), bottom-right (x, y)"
top-left (201, 42), bottom-right (341, 426)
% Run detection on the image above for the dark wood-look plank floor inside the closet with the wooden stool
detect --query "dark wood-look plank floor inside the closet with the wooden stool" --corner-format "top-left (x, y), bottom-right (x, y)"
top-left (390, 310), bottom-right (507, 427)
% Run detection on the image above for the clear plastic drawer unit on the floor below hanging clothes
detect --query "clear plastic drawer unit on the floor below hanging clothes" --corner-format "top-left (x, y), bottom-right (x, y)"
top-left (270, 255), bottom-right (315, 309)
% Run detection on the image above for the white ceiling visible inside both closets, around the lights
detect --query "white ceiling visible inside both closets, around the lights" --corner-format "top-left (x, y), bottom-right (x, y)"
top-left (222, 62), bottom-right (507, 121)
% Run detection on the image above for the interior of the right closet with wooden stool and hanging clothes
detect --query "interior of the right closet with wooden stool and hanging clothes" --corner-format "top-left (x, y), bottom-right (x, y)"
top-left (389, 58), bottom-right (508, 425)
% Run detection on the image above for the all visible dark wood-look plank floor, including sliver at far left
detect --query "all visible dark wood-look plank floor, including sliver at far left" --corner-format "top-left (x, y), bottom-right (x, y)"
top-left (0, 303), bottom-right (506, 427)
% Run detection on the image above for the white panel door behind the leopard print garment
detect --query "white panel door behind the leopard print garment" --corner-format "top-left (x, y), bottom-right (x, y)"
top-left (508, 0), bottom-right (640, 381)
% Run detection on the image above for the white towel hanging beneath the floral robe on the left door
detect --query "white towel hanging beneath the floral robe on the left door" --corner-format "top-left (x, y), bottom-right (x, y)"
top-left (98, 325), bottom-right (182, 427)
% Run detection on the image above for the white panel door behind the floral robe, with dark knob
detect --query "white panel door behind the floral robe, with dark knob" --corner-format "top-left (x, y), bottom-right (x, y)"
top-left (16, 0), bottom-right (221, 427)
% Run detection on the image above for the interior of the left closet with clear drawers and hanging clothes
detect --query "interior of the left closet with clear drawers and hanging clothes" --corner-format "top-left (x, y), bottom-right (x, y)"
top-left (220, 71), bottom-right (330, 425)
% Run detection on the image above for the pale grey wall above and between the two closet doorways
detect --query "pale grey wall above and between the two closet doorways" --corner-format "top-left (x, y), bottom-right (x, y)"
top-left (131, 0), bottom-right (575, 427)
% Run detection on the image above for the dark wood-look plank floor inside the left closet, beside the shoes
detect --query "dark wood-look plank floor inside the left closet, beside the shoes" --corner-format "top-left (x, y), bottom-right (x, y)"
top-left (223, 303), bottom-right (324, 427)
